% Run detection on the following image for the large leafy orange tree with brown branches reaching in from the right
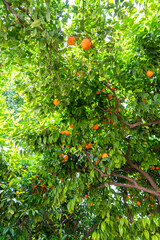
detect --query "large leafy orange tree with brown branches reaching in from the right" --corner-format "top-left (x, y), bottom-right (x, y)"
top-left (0, 0), bottom-right (160, 240)
